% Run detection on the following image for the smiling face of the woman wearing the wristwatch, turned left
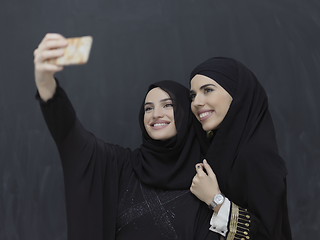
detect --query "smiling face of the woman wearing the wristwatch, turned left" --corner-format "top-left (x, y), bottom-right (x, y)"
top-left (190, 75), bottom-right (232, 131)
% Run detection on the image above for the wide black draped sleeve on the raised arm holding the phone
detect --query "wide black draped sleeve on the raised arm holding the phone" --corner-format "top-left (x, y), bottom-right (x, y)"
top-left (37, 81), bottom-right (132, 240)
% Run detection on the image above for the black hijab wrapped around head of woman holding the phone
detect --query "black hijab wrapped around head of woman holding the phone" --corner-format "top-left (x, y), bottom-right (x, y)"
top-left (133, 80), bottom-right (205, 189)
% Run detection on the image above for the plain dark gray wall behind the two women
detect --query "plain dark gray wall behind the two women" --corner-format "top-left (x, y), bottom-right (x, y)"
top-left (0, 0), bottom-right (320, 240)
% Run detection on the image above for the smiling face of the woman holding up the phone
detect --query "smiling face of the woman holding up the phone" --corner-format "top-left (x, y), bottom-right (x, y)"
top-left (143, 87), bottom-right (177, 140)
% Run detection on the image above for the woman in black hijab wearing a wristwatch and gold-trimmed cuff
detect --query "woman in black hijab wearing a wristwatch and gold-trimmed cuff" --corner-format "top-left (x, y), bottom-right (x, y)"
top-left (190, 57), bottom-right (292, 240)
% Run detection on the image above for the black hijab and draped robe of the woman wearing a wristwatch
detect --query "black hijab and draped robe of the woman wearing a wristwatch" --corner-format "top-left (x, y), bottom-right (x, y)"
top-left (190, 57), bottom-right (289, 239)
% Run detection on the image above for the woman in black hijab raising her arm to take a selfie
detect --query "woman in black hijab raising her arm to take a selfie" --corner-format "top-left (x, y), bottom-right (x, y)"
top-left (34, 34), bottom-right (220, 240)
